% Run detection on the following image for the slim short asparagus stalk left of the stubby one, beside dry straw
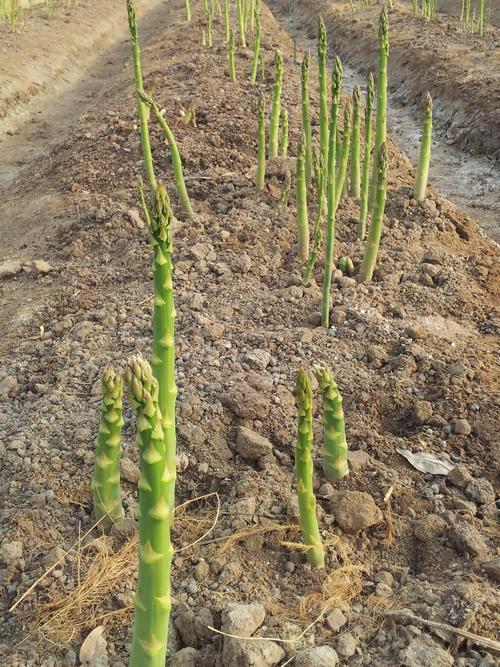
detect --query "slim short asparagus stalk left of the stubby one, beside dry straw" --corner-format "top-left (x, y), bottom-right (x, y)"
top-left (295, 369), bottom-right (325, 567)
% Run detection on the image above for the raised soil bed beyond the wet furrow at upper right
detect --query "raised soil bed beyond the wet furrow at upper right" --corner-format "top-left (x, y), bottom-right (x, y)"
top-left (269, 0), bottom-right (500, 159)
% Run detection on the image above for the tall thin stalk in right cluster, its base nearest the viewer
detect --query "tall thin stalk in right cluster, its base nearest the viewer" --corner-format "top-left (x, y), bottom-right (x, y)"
top-left (321, 57), bottom-right (343, 329)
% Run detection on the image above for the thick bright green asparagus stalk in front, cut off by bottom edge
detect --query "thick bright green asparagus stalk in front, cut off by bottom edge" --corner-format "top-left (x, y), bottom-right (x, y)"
top-left (127, 359), bottom-right (175, 667)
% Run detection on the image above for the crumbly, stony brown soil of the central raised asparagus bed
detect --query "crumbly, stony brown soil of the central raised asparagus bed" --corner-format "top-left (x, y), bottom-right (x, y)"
top-left (0, 0), bottom-right (500, 667)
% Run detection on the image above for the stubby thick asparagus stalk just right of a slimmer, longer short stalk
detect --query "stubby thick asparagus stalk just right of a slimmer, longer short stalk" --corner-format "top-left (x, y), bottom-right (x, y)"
top-left (313, 366), bottom-right (349, 482)
